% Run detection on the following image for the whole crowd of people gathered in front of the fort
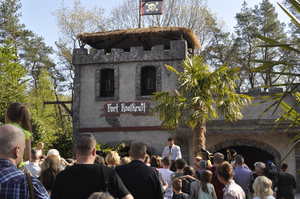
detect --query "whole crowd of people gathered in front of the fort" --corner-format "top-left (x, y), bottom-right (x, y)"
top-left (0, 104), bottom-right (296, 199)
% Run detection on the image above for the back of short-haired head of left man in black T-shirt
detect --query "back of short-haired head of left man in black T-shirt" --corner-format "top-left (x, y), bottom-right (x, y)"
top-left (75, 133), bottom-right (97, 156)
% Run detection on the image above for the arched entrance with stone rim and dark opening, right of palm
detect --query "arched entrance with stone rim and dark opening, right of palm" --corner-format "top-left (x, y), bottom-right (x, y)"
top-left (210, 139), bottom-right (281, 168)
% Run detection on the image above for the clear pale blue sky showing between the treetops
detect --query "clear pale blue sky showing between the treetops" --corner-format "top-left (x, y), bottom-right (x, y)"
top-left (21, 0), bottom-right (287, 49)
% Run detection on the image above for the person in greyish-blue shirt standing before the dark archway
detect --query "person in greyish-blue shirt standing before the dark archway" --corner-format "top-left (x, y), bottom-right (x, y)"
top-left (234, 155), bottom-right (252, 198)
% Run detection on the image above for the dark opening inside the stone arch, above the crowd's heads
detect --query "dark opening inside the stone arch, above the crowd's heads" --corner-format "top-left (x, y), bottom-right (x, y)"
top-left (219, 146), bottom-right (275, 169)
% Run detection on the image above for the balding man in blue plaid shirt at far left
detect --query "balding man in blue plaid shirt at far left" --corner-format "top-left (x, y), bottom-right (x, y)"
top-left (0, 124), bottom-right (49, 199)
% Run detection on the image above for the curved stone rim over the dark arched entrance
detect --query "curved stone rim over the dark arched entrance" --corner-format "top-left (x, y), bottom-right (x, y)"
top-left (209, 139), bottom-right (281, 163)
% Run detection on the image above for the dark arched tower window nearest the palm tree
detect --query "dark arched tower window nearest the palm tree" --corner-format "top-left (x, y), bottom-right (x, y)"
top-left (141, 66), bottom-right (156, 96)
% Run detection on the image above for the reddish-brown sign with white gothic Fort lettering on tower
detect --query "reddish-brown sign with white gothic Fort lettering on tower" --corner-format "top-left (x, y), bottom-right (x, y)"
top-left (104, 102), bottom-right (150, 114)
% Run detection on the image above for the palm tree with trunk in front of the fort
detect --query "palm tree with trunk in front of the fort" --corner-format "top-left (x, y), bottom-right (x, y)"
top-left (153, 56), bottom-right (251, 155)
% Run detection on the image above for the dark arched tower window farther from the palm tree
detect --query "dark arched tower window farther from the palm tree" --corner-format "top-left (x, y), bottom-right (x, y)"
top-left (100, 69), bottom-right (115, 97)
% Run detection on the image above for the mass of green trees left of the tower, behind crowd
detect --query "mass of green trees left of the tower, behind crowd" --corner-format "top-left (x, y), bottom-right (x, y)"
top-left (0, 0), bottom-right (72, 155)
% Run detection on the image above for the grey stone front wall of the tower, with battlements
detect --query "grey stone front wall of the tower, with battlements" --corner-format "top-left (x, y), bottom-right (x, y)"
top-left (73, 41), bottom-right (187, 148)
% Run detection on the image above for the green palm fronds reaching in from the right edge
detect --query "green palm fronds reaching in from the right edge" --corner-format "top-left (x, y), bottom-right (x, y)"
top-left (256, 0), bottom-right (300, 148)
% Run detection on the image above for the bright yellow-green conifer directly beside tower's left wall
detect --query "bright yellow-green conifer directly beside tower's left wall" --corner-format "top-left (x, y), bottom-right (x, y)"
top-left (28, 69), bottom-right (72, 157)
